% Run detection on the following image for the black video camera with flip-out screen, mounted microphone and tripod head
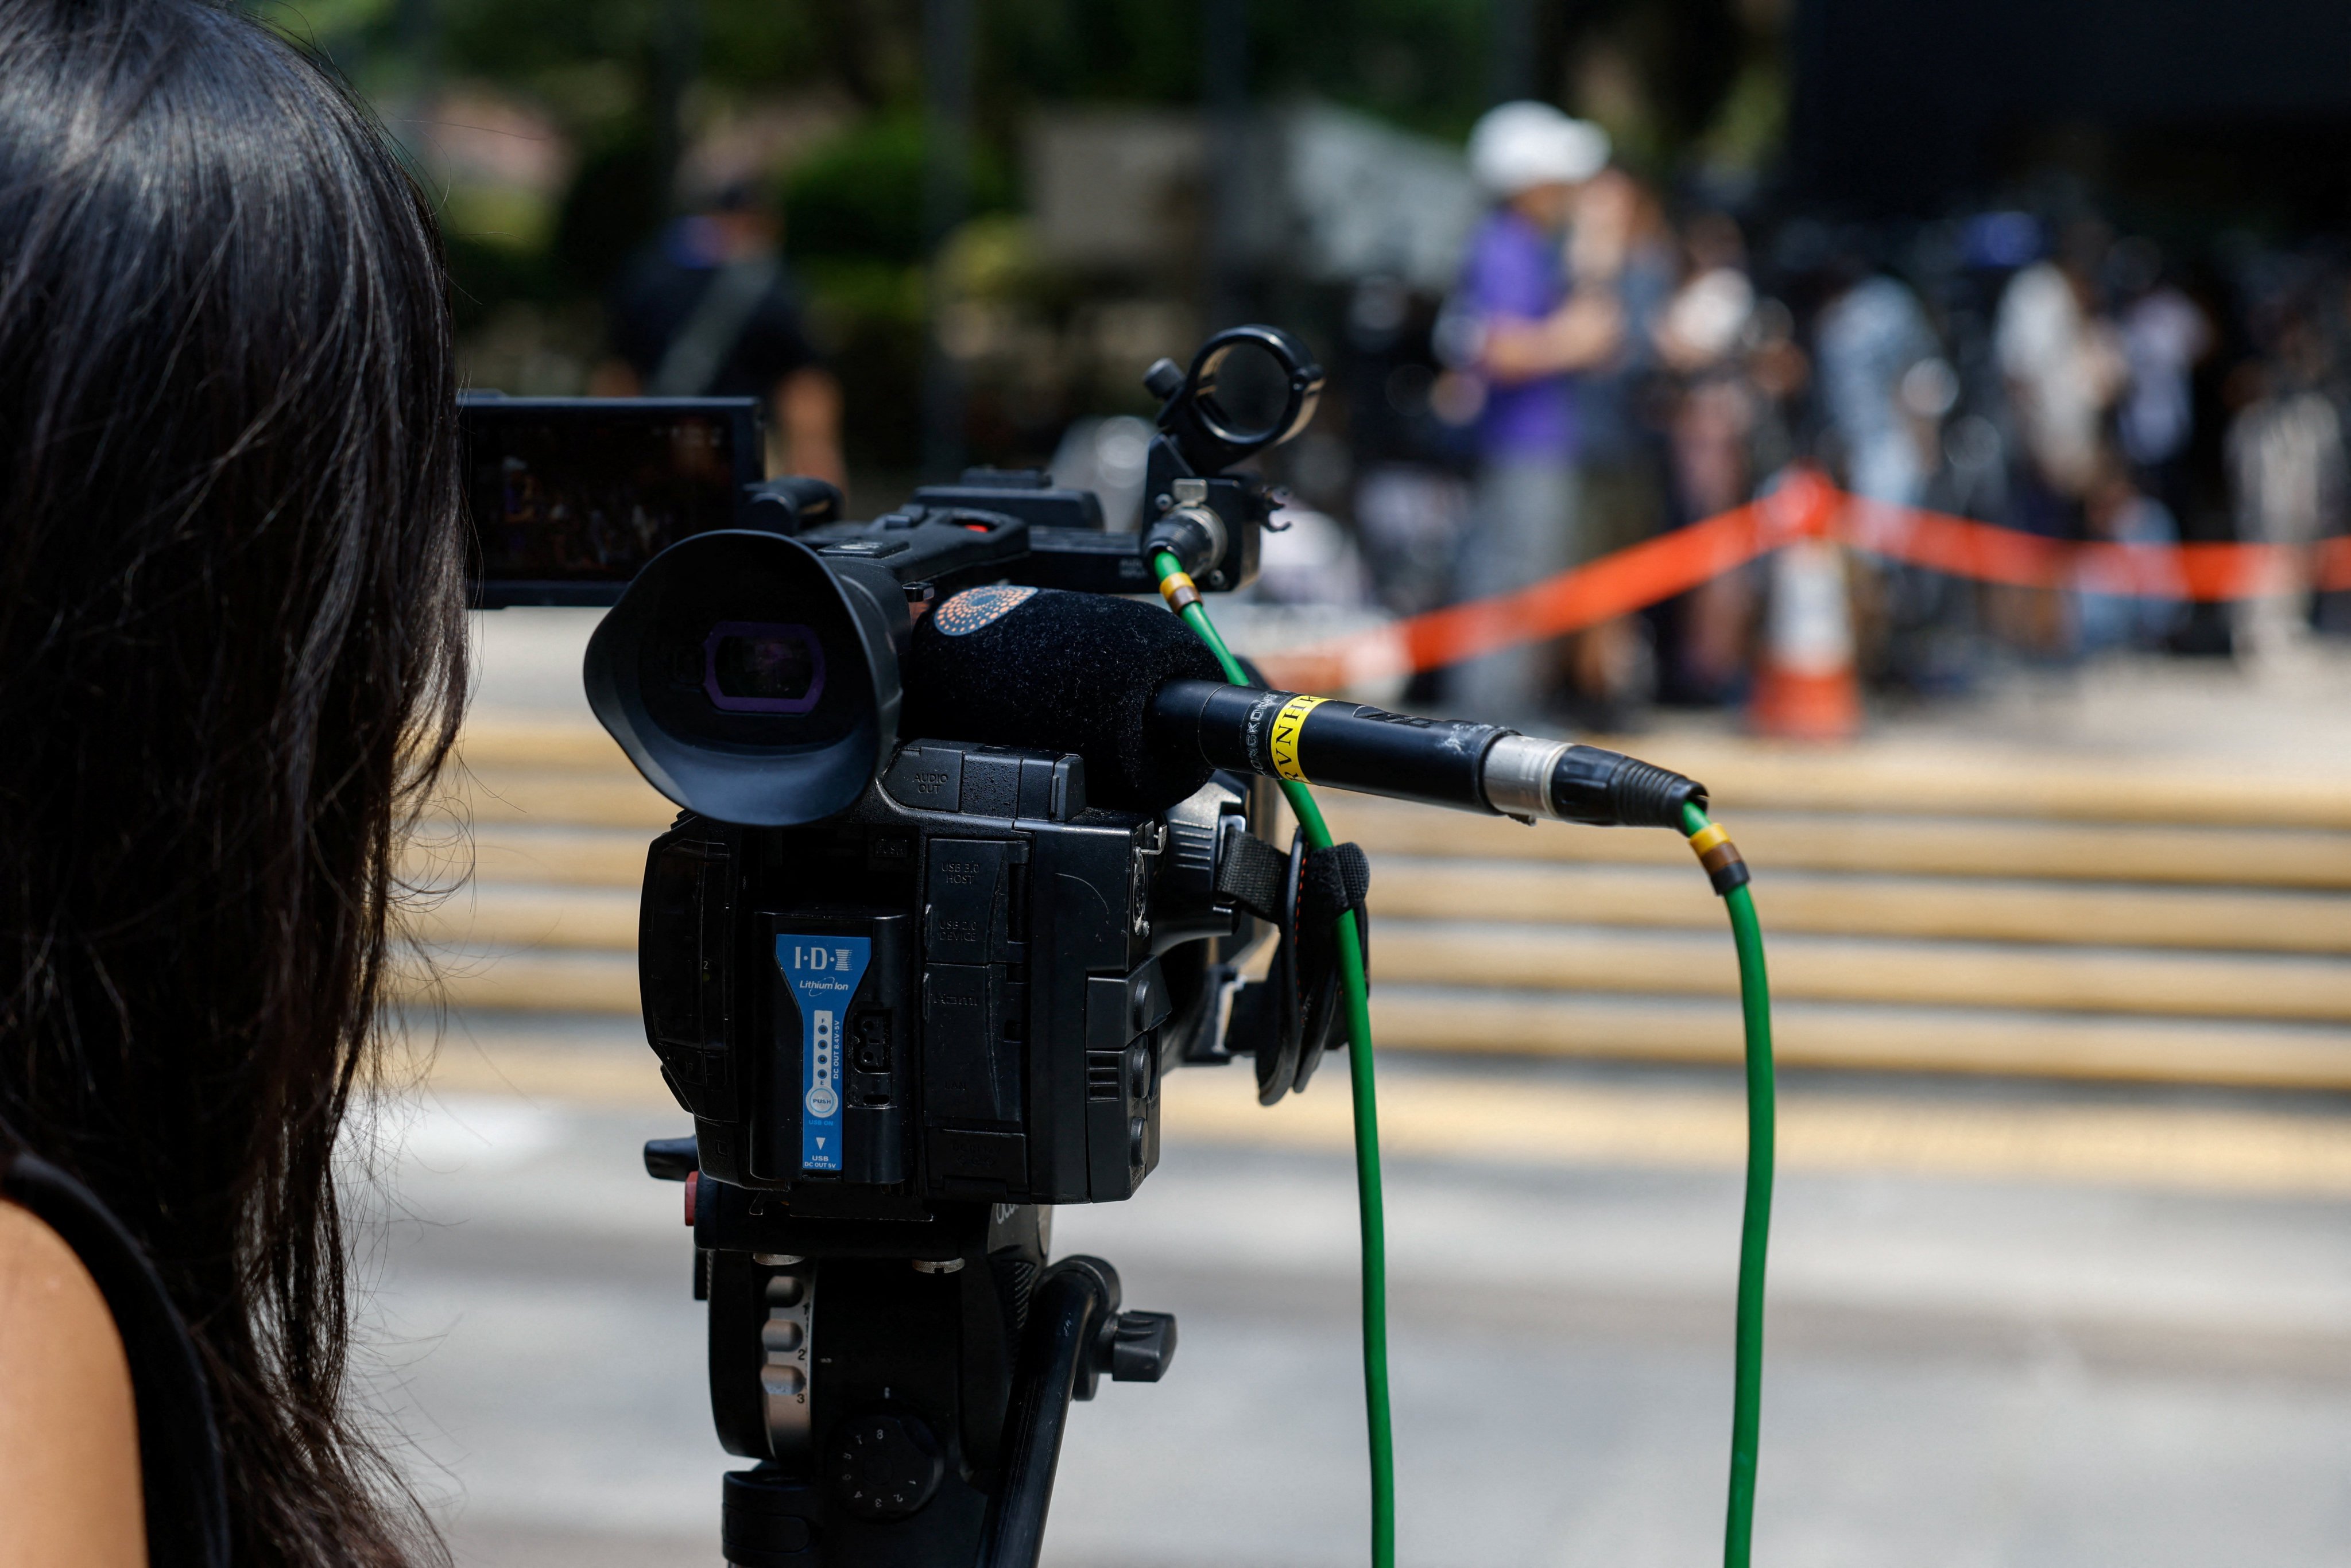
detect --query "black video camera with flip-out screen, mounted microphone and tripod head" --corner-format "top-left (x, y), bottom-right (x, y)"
top-left (463, 327), bottom-right (1702, 1568)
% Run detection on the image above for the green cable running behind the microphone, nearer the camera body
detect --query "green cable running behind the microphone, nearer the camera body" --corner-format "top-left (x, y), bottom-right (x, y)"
top-left (1152, 550), bottom-right (1392, 1568)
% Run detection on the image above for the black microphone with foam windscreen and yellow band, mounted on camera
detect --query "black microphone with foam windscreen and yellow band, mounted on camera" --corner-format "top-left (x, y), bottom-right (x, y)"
top-left (903, 585), bottom-right (1707, 830)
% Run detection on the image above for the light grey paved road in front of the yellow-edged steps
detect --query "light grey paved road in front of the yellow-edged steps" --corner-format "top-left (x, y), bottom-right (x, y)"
top-left (357, 1025), bottom-right (2351, 1568)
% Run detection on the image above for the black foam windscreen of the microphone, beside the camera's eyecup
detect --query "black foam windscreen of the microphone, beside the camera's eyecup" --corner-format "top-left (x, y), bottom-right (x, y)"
top-left (900, 583), bottom-right (1222, 811)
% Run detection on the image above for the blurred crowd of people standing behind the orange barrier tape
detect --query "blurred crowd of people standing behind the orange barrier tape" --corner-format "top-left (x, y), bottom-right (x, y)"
top-left (1269, 103), bottom-right (2351, 727)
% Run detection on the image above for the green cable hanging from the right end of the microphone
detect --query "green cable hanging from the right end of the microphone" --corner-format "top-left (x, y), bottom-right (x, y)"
top-left (1681, 806), bottom-right (1775, 1568)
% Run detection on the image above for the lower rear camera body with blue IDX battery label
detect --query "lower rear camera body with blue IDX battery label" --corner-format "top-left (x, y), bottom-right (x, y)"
top-left (637, 740), bottom-right (1262, 1220)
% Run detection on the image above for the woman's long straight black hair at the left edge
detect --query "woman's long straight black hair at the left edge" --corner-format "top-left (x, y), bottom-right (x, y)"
top-left (0, 0), bottom-right (463, 1566)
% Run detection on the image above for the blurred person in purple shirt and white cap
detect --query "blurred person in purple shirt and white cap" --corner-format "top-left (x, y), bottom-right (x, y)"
top-left (1448, 103), bottom-right (1625, 727)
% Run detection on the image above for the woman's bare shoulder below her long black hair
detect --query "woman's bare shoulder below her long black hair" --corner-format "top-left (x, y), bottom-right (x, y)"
top-left (0, 1201), bottom-right (146, 1568)
